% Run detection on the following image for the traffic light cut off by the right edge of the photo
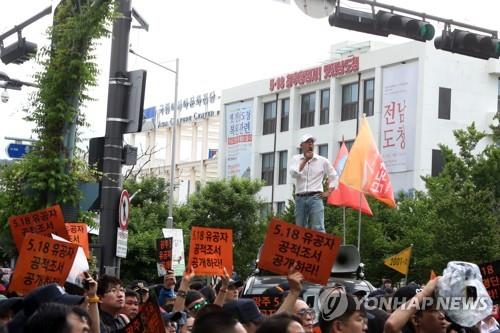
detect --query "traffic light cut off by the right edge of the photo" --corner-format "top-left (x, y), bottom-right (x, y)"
top-left (434, 29), bottom-right (500, 60)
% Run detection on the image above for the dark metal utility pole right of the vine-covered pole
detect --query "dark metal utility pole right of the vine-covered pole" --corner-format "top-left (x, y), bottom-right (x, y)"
top-left (99, 0), bottom-right (132, 275)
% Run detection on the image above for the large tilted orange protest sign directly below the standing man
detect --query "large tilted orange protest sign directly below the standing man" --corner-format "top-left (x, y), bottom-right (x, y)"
top-left (259, 219), bottom-right (342, 284)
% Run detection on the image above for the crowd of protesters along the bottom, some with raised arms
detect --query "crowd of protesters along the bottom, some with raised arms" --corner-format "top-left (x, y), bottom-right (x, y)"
top-left (0, 268), bottom-right (500, 333)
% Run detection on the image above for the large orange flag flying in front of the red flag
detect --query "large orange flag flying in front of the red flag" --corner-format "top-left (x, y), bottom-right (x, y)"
top-left (340, 117), bottom-right (396, 207)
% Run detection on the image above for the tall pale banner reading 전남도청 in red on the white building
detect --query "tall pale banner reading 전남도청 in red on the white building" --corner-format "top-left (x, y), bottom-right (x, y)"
top-left (380, 61), bottom-right (418, 172)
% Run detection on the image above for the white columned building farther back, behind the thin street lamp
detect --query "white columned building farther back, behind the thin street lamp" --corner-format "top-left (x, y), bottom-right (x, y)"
top-left (126, 92), bottom-right (220, 203)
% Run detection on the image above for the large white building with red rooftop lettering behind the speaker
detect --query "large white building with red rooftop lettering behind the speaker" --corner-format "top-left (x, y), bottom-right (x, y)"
top-left (219, 42), bottom-right (500, 212)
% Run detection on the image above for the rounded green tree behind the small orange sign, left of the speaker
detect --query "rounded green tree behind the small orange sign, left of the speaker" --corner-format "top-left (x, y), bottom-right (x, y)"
top-left (174, 178), bottom-right (267, 277)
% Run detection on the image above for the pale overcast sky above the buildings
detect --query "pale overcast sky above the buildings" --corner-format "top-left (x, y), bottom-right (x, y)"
top-left (0, 0), bottom-right (500, 158)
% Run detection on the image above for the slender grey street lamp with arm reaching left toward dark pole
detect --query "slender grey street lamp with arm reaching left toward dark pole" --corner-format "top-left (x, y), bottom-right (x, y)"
top-left (129, 49), bottom-right (179, 229)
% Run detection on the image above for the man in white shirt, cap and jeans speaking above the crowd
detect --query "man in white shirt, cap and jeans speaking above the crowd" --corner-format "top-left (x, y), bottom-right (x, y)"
top-left (289, 134), bottom-right (339, 232)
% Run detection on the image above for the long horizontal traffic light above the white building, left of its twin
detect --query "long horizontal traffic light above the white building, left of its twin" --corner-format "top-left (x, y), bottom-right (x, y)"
top-left (329, 7), bottom-right (435, 42)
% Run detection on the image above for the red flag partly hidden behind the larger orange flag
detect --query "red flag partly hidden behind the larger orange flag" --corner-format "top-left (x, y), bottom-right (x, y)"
top-left (326, 141), bottom-right (373, 216)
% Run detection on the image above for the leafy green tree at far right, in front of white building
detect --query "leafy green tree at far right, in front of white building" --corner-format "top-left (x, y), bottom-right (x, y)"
top-left (424, 123), bottom-right (500, 267)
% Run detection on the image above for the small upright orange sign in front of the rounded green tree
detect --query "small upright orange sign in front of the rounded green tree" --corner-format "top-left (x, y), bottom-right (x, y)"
top-left (188, 227), bottom-right (233, 276)
